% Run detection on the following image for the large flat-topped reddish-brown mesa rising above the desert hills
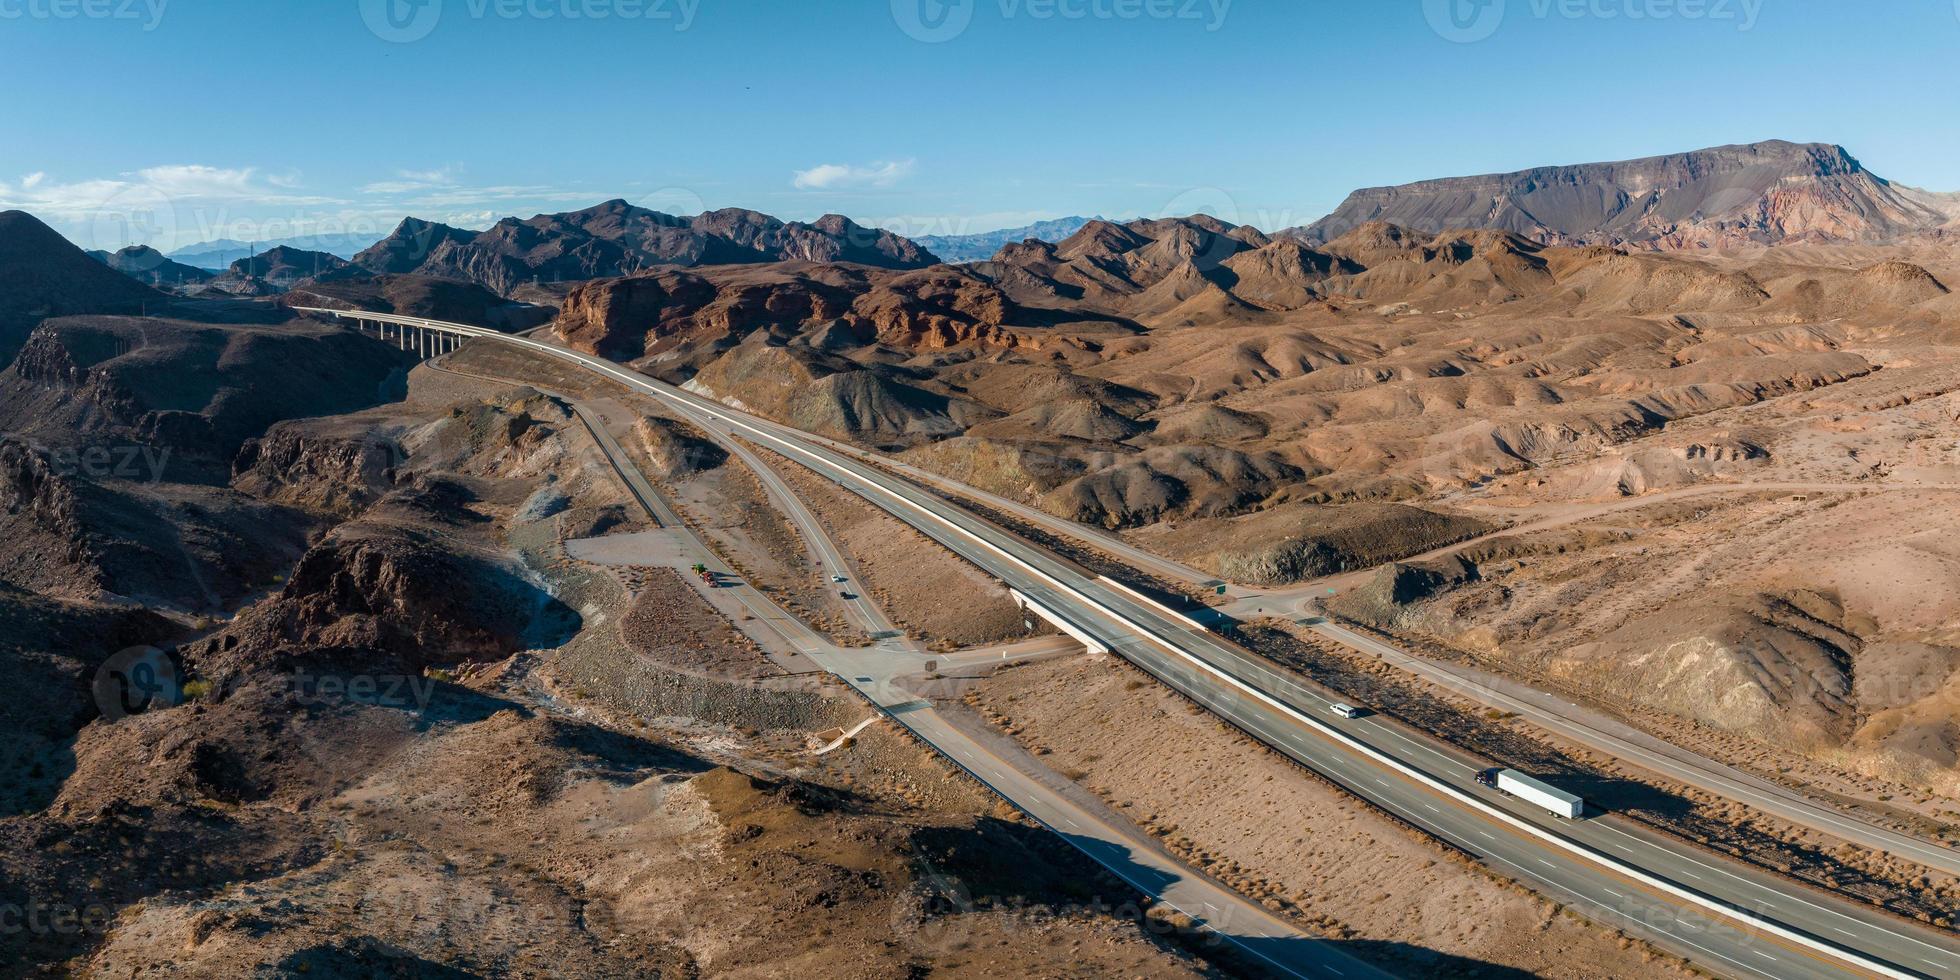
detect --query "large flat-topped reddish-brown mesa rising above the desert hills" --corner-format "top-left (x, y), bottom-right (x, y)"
top-left (1286, 139), bottom-right (1960, 249)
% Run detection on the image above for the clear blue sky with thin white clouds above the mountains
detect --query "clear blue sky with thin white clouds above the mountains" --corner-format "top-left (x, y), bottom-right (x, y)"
top-left (0, 0), bottom-right (1960, 247)
